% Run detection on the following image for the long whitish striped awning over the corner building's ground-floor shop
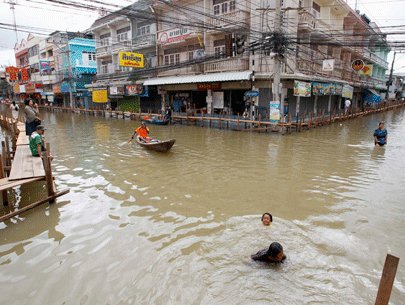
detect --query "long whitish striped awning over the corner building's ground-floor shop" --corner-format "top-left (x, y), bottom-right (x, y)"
top-left (143, 71), bottom-right (252, 86)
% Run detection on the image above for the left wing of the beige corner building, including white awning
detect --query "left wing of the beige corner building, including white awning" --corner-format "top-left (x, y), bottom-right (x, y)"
top-left (144, 0), bottom-right (252, 113)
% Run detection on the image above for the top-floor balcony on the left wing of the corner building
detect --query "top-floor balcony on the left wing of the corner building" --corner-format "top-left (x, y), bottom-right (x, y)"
top-left (207, 10), bottom-right (250, 31)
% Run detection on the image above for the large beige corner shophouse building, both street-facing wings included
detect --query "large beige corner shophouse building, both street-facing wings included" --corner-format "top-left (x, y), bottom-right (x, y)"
top-left (140, 0), bottom-right (389, 117)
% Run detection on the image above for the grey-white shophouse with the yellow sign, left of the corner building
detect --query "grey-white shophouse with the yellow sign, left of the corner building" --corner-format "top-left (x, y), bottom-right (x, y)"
top-left (89, 1), bottom-right (160, 111)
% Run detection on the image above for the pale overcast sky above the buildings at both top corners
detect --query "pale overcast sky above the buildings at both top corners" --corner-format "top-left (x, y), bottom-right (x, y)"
top-left (0, 0), bottom-right (405, 73)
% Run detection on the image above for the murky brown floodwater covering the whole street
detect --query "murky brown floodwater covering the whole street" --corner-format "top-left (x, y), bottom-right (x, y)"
top-left (0, 109), bottom-right (405, 305)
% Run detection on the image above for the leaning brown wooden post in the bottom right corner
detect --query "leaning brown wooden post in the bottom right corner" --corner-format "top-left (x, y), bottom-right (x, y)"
top-left (375, 254), bottom-right (399, 305)
